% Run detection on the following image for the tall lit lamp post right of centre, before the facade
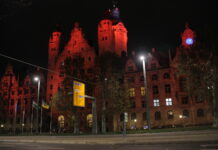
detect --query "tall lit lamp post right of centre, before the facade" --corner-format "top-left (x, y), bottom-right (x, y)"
top-left (140, 56), bottom-right (151, 130)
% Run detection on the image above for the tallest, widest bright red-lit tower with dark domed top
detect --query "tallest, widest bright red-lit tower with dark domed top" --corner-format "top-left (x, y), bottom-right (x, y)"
top-left (98, 4), bottom-right (128, 56)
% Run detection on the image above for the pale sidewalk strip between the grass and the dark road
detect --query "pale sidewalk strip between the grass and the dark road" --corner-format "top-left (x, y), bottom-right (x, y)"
top-left (0, 130), bottom-right (218, 144)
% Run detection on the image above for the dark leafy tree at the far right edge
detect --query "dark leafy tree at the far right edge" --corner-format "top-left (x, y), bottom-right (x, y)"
top-left (178, 45), bottom-right (218, 127)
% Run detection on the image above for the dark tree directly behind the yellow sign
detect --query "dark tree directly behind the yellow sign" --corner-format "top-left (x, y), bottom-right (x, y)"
top-left (54, 55), bottom-right (85, 134)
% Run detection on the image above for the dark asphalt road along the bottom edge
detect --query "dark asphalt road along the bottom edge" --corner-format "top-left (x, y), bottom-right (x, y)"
top-left (0, 141), bottom-right (218, 150)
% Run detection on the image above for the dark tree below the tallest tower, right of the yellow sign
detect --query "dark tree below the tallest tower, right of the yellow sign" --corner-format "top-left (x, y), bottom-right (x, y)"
top-left (96, 52), bottom-right (129, 133)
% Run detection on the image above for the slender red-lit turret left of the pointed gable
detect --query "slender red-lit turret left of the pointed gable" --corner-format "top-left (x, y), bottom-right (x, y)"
top-left (48, 27), bottom-right (61, 69)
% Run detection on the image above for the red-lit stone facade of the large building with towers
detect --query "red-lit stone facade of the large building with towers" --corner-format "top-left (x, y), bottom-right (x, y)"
top-left (0, 4), bottom-right (212, 131)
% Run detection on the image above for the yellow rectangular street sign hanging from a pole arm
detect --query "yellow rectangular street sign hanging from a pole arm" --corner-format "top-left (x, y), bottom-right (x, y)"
top-left (73, 81), bottom-right (85, 107)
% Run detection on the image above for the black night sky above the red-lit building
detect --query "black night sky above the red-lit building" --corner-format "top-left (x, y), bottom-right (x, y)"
top-left (0, 0), bottom-right (218, 74)
